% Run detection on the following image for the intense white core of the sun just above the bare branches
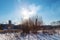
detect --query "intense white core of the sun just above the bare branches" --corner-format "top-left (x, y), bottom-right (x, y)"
top-left (21, 8), bottom-right (34, 20)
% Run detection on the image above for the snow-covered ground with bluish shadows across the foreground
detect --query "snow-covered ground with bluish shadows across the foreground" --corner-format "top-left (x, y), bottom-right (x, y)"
top-left (0, 32), bottom-right (60, 40)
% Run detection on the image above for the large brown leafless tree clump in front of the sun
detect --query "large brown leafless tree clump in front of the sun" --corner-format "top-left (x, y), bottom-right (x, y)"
top-left (22, 16), bottom-right (43, 33)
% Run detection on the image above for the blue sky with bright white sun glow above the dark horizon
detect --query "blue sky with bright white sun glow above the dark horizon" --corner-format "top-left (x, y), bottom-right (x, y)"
top-left (0, 0), bottom-right (60, 24)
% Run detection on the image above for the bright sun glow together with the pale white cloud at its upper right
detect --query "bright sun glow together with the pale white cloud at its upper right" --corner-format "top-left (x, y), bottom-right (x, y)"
top-left (21, 5), bottom-right (39, 20)
